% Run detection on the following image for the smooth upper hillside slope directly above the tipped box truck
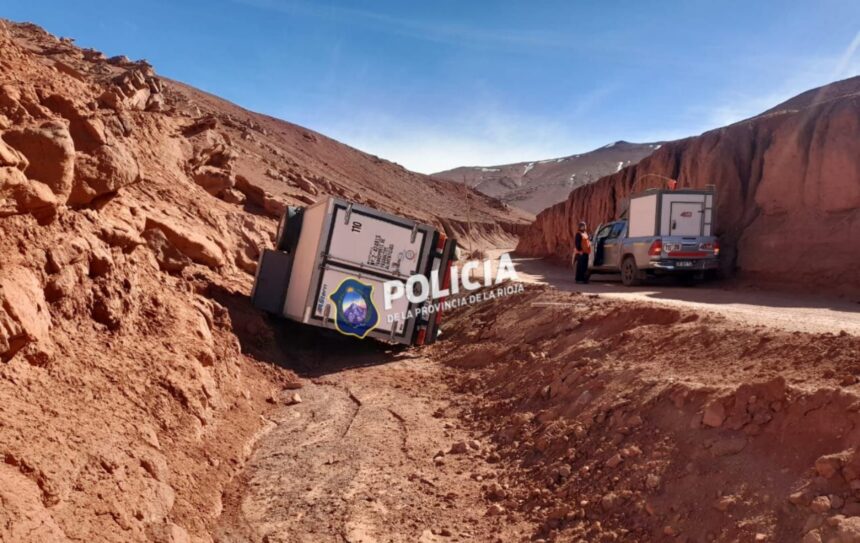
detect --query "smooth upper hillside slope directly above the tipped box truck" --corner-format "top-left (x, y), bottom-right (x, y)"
top-left (165, 81), bottom-right (532, 235)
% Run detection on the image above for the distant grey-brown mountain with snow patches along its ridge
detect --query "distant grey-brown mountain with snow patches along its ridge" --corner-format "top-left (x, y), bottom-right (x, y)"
top-left (433, 141), bottom-right (660, 213)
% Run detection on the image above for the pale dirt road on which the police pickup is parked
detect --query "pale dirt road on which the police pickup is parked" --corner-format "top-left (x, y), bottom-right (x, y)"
top-left (514, 258), bottom-right (860, 336)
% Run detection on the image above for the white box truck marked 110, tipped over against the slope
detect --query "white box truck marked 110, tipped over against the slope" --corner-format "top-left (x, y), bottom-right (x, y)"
top-left (251, 197), bottom-right (456, 345)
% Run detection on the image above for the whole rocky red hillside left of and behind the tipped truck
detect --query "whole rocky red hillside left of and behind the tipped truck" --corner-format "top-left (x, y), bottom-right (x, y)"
top-left (0, 21), bottom-right (527, 543)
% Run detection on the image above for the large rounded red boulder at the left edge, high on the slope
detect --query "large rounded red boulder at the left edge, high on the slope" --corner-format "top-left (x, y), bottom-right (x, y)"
top-left (2, 121), bottom-right (75, 202)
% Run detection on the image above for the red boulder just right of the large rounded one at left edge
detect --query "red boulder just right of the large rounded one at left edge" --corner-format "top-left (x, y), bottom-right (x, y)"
top-left (68, 144), bottom-right (140, 205)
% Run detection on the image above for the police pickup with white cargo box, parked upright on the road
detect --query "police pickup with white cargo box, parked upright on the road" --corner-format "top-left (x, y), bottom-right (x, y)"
top-left (588, 189), bottom-right (720, 286)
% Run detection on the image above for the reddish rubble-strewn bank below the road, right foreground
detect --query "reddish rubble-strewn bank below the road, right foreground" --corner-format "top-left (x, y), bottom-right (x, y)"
top-left (434, 287), bottom-right (860, 542)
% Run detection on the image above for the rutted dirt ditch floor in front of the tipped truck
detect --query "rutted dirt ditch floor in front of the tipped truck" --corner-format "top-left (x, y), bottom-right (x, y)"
top-left (217, 331), bottom-right (528, 543)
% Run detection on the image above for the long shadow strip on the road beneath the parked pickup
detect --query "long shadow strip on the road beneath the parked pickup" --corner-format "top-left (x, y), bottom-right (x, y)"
top-left (514, 258), bottom-right (860, 317)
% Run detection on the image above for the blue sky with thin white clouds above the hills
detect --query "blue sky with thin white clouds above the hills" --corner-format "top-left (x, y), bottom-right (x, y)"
top-left (0, 0), bottom-right (860, 172)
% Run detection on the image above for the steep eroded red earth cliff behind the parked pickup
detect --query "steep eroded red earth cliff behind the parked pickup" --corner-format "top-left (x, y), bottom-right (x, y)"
top-left (518, 77), bottom-right (860, 292)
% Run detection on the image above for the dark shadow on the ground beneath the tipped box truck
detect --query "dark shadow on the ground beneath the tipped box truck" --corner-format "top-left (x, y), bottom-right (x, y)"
top-left (205, 284), bottom-right (408, 378)
